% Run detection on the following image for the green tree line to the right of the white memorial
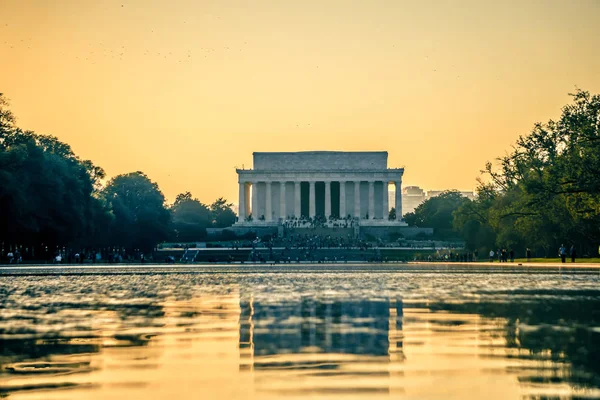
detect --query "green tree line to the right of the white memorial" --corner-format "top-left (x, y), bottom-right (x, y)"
top-left (405, 90), bottom-right (600, 257)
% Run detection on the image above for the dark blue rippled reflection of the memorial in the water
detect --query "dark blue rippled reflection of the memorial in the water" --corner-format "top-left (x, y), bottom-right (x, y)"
top-left (240, 297), bottom-right (402, 369)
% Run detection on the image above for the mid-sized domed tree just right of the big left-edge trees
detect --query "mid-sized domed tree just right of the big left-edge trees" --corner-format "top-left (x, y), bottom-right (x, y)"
top-left (102, 171), bottom-right (170, 251)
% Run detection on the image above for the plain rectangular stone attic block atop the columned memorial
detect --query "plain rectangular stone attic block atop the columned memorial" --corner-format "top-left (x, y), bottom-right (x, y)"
top-left (253, 151), bottom-right (388, 171)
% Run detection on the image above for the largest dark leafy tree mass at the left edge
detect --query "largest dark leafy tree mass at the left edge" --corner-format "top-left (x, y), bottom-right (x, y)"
top-left (0, 123), bottom-right (104, 249)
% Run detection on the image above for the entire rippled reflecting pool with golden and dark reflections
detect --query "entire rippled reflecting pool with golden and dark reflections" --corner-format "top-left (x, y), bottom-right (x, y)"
top-left (0, 265), bottom-right (600, 400)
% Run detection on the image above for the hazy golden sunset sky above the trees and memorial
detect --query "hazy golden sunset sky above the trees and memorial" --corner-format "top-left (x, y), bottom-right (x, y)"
top-left (0, 0), bottom-right (600, 203)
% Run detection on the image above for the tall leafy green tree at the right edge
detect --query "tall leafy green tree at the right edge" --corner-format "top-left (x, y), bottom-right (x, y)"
top-left (485, 90), bottom-right (600, 255)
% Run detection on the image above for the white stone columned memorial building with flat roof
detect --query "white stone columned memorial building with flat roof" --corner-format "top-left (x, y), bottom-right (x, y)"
top-left (236, 151), bottom-right (404, 225)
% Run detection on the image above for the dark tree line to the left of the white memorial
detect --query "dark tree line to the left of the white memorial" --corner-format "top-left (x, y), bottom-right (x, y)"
top-left (0, 93), bottom-right (236, 258)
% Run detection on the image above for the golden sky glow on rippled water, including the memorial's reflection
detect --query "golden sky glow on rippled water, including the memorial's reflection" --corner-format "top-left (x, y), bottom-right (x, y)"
top-left (0, 286), bottom-right (600, 400)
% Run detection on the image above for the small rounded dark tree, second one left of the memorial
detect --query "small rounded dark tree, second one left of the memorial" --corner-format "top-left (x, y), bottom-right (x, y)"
top-left (169, 192), bottom-right (211, 242)
